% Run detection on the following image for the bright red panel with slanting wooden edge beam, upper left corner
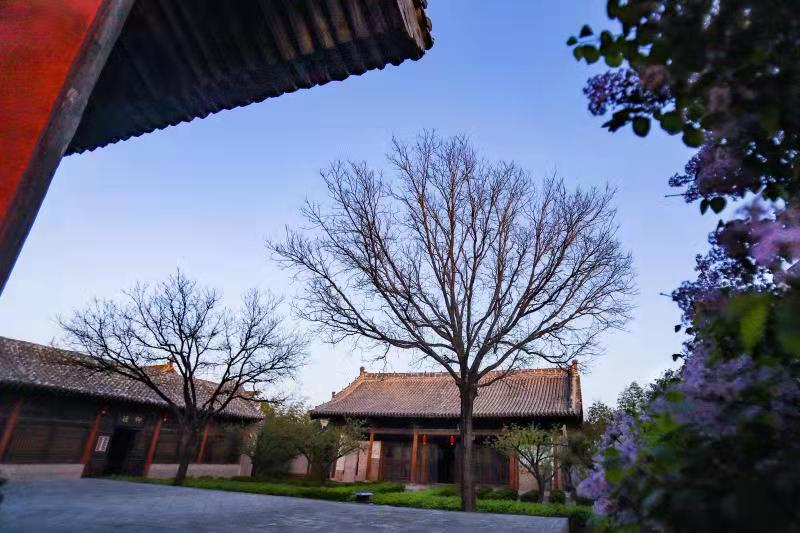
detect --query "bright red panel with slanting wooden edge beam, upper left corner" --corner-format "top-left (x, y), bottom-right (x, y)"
top-left (0, 0), bottom-right (135, 294)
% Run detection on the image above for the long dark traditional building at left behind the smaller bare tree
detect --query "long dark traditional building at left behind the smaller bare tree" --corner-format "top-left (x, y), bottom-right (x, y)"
top-left (0, 337), bottom-right (263, 479)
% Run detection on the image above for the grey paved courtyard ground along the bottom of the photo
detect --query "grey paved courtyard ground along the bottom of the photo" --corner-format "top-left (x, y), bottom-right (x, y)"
top-left (0, 479), bottom-right (568, 533)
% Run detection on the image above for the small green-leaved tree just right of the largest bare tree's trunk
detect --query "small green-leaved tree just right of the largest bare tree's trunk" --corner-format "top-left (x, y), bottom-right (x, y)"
top-left (494, 425), bottom-right (564, 502)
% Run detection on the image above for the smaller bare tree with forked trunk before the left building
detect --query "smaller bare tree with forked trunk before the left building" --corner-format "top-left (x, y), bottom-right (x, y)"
top-left (59, 270), bottom-right (305, 485)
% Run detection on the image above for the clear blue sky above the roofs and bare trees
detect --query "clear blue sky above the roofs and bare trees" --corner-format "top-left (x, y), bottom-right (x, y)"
top-left (0, 0), bottom-right (716, 404)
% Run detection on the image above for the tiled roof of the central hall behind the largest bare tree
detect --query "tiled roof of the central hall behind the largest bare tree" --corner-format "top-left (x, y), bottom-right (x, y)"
top-left (311, 365), bottom-right (582, 418)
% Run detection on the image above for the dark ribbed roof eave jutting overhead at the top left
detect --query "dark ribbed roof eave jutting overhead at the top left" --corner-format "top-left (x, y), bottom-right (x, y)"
top-left (67, 0), bottom-right (433, 154)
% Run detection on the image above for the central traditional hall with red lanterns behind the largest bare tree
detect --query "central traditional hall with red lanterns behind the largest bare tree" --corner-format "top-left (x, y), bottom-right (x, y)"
top-left (306, 362), bottom-right (583, 492)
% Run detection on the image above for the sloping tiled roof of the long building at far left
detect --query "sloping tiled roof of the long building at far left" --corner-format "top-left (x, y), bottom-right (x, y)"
top-left (0, 337), bottom-right (263, 420)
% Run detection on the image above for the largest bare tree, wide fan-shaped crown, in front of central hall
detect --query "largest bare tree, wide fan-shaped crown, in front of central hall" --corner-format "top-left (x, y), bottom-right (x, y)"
top-left (268, 133), bottom-right (633, 511)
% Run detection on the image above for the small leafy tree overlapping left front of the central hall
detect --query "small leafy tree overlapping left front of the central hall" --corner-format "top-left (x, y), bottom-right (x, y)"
top-left (296, 415), bottom-right (364, 482)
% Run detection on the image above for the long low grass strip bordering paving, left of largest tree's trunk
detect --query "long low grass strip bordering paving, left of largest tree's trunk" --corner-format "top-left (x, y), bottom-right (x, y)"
top-left (115, 477), bottom-right (404, 502)
